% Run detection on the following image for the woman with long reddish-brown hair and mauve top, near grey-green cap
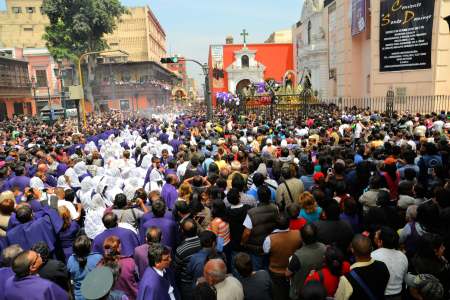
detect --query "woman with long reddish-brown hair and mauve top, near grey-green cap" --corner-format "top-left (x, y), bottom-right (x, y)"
top-left (98, 235), bottom-right (139, 300)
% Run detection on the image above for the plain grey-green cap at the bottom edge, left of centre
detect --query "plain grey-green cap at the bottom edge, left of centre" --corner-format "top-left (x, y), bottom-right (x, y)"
top-left (80, 267), bottom-right (114, 299)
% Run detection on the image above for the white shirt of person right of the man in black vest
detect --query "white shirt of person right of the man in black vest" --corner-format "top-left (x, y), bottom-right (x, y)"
top-left (371, 248), bottom-right (408, 296)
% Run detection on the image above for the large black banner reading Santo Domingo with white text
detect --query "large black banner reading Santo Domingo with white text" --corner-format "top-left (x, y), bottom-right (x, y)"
top-left (380, 0), bottom-right (434, 72)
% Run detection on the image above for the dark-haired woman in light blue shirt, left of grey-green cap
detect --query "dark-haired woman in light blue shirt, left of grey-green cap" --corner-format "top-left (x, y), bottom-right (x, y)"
top-left (67, 235), bottom-right (102, 300)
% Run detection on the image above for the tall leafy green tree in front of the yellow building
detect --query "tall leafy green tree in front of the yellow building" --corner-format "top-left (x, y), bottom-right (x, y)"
top-left (42, 0), bottom-right (127, 103)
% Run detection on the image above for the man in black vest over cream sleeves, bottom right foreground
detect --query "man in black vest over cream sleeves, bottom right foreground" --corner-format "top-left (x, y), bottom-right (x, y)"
top-left (334, 234), bottom-right (390, 300)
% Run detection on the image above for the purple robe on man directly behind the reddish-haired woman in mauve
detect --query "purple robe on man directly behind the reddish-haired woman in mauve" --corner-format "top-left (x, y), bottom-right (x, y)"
top-left (92, 227), bottom-right (139, 256)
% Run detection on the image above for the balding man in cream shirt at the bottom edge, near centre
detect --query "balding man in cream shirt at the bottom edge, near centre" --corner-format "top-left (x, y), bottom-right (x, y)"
top-left (203, 259), bottom-right (244, 300)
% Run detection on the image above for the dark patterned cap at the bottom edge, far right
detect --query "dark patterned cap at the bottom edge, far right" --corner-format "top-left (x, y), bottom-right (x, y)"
top-left (405, 273), bottom-right (444, 300)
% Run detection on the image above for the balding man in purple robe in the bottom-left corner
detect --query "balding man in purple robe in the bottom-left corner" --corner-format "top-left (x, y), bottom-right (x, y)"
top-left (4, 251), bottom-right (69, 300)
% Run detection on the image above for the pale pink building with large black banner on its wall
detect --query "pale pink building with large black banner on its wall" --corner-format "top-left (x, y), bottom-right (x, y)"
top-left (293, 0), bottom-right (450, 97)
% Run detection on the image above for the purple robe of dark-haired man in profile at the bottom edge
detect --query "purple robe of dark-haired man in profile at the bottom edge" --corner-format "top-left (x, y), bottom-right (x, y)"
top-left (137, 267), bottom-right (180, 300)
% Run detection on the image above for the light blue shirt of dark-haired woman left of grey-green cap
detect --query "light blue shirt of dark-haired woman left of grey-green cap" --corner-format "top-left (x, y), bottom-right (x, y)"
top-left (67, 253), bottom-right (102, 300)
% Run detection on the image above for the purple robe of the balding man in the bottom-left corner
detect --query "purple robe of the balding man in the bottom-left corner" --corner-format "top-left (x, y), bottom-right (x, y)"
top-left (5, 275), bottom-right (69, 300)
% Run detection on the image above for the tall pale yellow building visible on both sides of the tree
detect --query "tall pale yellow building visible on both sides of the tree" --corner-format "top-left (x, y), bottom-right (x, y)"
top-left (0, 0), bottom-right (166, 62)
